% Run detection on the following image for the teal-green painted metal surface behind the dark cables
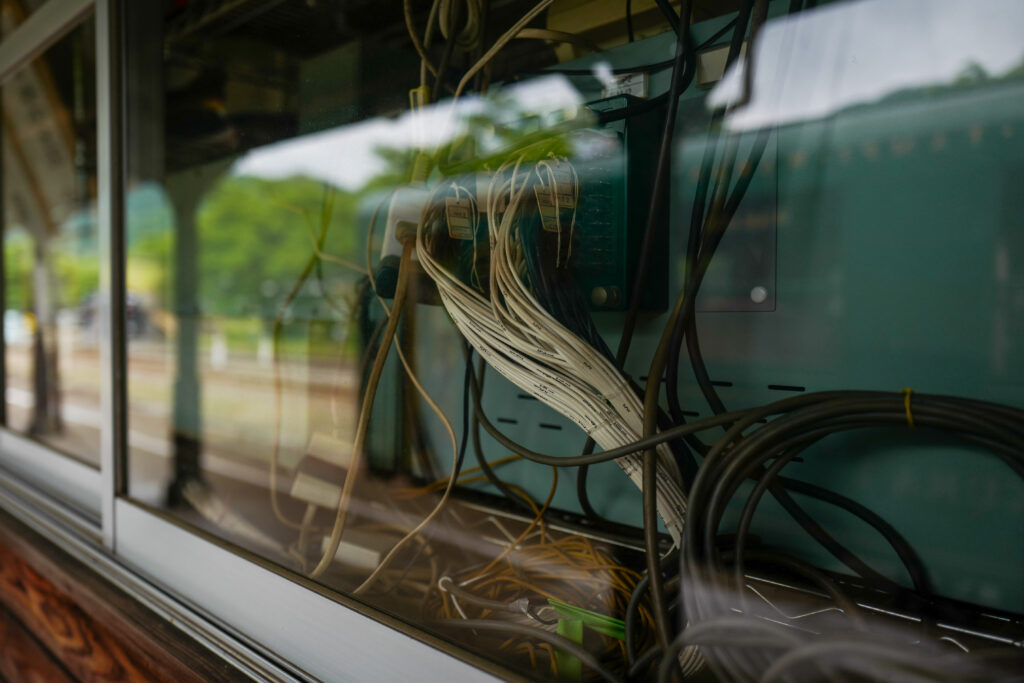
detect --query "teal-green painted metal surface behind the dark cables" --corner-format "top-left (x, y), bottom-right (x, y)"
top-left (401, 13), bottom-right (1024, 611)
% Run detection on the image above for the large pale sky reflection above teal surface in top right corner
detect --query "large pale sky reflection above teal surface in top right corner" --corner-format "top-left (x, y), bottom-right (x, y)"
top-left (709, 0), bottom-right (1024, 129)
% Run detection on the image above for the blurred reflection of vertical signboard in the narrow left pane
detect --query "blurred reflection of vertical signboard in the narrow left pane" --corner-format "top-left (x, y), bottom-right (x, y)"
top-left (0, 0), bottom-right (77, 237)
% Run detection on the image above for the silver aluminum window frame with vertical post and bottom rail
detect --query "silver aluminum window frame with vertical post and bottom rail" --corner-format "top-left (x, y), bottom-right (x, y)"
top-left (0, 0), bottom-right (499, 681)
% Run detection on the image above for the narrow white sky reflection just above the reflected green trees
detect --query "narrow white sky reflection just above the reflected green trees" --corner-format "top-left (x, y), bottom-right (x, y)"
top-left (232, 76), bottom-right (582, 190)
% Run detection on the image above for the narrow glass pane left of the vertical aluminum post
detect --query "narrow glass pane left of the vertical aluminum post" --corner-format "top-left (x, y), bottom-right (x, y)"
top-left (3, 15), bottom-right (100, 466)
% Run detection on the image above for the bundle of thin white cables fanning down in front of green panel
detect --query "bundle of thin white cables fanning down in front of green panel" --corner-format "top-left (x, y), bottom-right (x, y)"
top-left (416, 157), bottom-right (686, 543)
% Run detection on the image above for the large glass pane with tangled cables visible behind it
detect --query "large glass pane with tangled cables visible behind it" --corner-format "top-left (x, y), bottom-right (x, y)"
top-left (126, 0), bottom-right (1024, 680)
